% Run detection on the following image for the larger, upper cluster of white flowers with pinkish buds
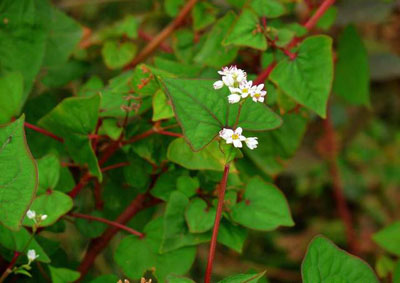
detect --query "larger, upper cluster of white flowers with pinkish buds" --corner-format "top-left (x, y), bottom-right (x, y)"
top-left (213, 66), bottom-right (267, 103)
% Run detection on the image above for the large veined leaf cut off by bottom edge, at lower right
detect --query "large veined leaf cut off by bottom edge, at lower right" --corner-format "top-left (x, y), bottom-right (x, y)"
top-left (301, 236), bottom-right (379, 283)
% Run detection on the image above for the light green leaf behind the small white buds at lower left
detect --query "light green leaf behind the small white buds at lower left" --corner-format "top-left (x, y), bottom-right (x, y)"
top-left (23, 190), bottom-right (73, 227)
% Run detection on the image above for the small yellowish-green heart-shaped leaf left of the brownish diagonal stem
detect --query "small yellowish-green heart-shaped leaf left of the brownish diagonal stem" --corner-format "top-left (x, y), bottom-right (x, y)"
top-left (101, 40), bottom-right (137, 69)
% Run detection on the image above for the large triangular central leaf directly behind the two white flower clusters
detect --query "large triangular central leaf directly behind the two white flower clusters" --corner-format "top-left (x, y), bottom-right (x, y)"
top-left (160, 78), bottom-right (281, 151)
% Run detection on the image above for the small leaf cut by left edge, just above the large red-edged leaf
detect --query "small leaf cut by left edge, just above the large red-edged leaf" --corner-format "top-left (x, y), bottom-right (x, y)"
top-left (0, 72), bottom-right (24, 124)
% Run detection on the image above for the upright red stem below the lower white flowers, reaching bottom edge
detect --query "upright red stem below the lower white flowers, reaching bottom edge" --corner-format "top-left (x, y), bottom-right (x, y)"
top-left (204, 164), bottom-right (229, 283)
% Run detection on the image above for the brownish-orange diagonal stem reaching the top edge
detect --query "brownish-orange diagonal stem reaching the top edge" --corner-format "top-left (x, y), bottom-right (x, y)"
top-left (127, 0), bottom-right (197, 68)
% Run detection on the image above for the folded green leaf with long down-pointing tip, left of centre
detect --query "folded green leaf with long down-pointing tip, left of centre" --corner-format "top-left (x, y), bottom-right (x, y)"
top-left (39, 95), bottom-right (102, 179)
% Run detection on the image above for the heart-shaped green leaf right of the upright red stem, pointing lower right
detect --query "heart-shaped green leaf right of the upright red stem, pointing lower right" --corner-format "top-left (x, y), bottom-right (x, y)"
top-left (231, 178), bottom-right (294, 231)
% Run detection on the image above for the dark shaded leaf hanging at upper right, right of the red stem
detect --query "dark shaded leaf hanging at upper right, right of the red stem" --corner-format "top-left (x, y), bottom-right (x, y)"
top-left (333, 26), bottom-right (370, 106)
